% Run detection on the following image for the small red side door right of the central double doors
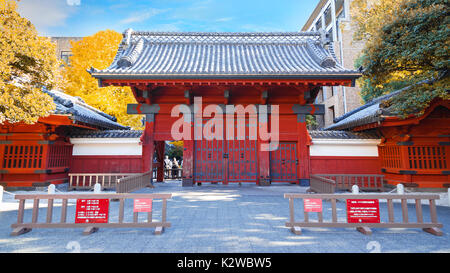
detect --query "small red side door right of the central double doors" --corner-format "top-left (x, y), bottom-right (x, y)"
top-left (270, 142), bottom-right (298, 182)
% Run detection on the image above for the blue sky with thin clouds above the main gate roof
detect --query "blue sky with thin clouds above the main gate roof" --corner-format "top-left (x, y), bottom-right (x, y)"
top-left (19, 0), bottom-right (319, 36)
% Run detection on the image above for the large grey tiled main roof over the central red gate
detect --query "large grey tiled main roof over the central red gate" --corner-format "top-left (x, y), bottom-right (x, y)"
top-left (89, 30), bottom-right (360, 79)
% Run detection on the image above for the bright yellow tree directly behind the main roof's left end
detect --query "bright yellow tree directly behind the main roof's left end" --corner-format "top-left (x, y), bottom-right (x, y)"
top-left (62, 30), bottom-right (142, 129)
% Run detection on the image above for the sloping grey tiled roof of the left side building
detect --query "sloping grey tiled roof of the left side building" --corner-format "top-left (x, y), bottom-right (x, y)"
top-left (43, 90), bottom-right (128, 129)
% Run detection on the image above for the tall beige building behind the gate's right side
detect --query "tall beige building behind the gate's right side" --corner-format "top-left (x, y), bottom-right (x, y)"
top-left (302, 0), bottom-right (364, 128)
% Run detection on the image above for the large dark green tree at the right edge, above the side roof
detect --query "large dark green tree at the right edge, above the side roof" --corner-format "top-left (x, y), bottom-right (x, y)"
top-left (355, 0), bottom-right (450, 117)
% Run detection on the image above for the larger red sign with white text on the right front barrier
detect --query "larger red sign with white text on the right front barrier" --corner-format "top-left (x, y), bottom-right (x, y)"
top-left (347, 199), bottom-right (380, 223)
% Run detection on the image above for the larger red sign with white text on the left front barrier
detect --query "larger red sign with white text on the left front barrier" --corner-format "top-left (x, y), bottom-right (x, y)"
top-left (75, 199), bottom-right (109, 224)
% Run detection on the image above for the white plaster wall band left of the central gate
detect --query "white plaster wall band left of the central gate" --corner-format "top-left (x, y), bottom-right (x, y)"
top-left (70, 138), bottom-right (142, 155)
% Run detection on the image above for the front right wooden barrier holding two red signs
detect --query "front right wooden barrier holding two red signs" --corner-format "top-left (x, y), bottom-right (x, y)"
top-left (284, 193), bottom-right (443, 236)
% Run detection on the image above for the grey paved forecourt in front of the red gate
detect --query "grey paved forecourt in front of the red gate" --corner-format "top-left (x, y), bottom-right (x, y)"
top-left (0, 181), bottom-right (450, 253)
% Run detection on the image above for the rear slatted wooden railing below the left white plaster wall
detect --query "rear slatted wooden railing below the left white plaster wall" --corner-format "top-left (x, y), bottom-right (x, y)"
top-left (69, 173), bottom-right (138, 190)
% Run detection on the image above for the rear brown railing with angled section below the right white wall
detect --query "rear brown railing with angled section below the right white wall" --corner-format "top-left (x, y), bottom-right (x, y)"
top-left (310, 174), bottom-right (384, 193)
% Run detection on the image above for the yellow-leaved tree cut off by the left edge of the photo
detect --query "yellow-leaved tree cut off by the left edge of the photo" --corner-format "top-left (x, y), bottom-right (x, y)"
top-left (0, 0), bottom-right (59, 124)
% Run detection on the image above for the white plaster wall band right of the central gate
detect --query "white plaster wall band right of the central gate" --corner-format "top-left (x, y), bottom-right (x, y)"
top-left (309, 139), bottom-right (380, 156)
